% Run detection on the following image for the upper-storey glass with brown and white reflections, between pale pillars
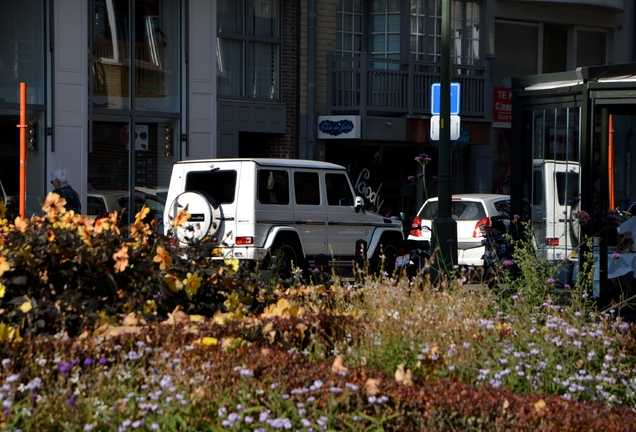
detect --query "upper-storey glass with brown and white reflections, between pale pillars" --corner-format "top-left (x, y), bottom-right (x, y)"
top-left (92, 0), bottom-right (180, 112)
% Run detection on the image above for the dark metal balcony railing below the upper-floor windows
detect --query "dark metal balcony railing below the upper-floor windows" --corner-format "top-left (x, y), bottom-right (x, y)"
top-left (327, 54), bottom-right (487, 118)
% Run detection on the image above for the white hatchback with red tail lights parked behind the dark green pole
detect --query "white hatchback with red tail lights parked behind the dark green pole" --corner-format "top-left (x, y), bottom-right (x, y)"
top-left (408, 194), bottom-right (511, 266)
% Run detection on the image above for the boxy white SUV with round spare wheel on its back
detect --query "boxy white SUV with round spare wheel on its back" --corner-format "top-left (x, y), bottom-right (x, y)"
top-left (164, 159), bottom-right (404, 270)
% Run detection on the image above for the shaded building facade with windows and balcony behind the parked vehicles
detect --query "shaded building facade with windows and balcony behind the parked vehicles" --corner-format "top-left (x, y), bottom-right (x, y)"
top-left (0, 0), bottom-right (636, 221)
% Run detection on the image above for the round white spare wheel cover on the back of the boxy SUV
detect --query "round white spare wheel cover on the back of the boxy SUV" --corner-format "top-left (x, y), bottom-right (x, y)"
top-left (171, 192), bottom-right (221, 243)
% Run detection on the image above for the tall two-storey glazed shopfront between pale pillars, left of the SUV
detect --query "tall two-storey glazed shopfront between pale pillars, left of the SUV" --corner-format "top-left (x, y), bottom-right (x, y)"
top-left (87, 0), bottom-right (183, 228)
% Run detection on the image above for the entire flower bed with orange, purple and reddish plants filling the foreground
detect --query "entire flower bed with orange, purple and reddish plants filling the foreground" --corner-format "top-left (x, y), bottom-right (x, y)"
top-left (0, 196), bottom-right (636, 431)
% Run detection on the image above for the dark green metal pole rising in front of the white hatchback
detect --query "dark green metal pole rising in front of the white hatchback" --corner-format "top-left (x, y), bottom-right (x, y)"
top-left (433, 0), bottom-right (457, 276)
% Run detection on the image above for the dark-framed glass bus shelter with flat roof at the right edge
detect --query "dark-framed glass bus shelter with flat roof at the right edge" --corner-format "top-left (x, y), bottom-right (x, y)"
top-left (508, 63), bottom-right (636, 316)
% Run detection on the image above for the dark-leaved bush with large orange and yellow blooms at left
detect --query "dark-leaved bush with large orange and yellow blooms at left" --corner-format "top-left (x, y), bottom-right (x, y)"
top-left (0, 193), bottom-right (261, 334)
